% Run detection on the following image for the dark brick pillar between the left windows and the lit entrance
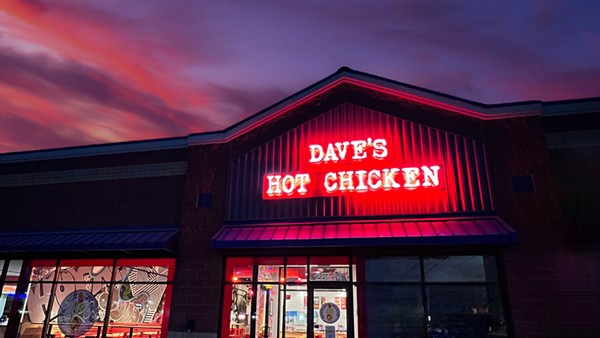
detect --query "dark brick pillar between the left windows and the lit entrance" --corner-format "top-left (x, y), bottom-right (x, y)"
top-left (169, 144), bottom-right (229, 334)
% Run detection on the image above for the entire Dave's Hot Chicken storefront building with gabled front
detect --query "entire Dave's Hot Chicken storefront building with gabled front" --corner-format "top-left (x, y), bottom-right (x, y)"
top-left (0, 68), bottom-right (600, 338)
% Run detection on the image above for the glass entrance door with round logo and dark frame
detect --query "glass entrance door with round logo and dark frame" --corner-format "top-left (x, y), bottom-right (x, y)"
top-left (309, 285), bottom-right (354, 338)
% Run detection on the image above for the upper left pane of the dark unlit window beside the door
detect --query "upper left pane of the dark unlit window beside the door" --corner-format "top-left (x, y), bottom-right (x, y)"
top-left (365, 257), bottom-right (421, 282)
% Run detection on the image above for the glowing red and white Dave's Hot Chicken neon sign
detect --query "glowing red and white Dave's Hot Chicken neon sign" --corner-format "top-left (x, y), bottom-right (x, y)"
top-left (263, 138), bottom-right (441, 199)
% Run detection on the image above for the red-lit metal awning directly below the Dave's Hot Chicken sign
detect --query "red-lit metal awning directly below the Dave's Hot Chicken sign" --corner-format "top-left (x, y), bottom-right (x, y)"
top-left (212, 216), bottom-right (516, 249)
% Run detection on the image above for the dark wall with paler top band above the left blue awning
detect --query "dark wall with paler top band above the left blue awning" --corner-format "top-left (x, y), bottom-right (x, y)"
top-left (0, 151), bottom-right (187, 231)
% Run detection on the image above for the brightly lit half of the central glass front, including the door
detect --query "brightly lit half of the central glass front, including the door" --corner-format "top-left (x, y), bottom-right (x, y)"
top-left (221, 256), bottom-right (357, 338)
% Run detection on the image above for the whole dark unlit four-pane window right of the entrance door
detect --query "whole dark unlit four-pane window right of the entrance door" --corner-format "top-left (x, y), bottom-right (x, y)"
top-left (365, 256), bottom-right (507, 338)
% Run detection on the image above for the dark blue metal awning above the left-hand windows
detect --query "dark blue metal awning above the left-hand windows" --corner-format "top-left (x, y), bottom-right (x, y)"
top-left (0, 228), bottom-right (179, 253)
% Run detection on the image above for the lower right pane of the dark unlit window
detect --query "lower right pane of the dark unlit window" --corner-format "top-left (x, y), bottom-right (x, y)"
top-left (427, 285), bottom-right (507, 338)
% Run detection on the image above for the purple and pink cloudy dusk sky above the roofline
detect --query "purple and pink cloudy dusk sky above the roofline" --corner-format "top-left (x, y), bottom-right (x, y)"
top-left (0, 0), bottom-right (600, 153)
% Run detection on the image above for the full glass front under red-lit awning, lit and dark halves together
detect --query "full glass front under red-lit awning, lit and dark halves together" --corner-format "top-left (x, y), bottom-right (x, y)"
top-left (221, 255), bottom-right (507, 338)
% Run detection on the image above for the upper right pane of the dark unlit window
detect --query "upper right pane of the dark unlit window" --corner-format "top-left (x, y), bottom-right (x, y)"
top-left (423, 256), bottom-right (496, 282)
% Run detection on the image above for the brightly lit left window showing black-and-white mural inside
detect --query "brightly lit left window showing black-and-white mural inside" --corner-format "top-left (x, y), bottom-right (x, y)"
top-left (12, 259), bottom-right (174, 338)
